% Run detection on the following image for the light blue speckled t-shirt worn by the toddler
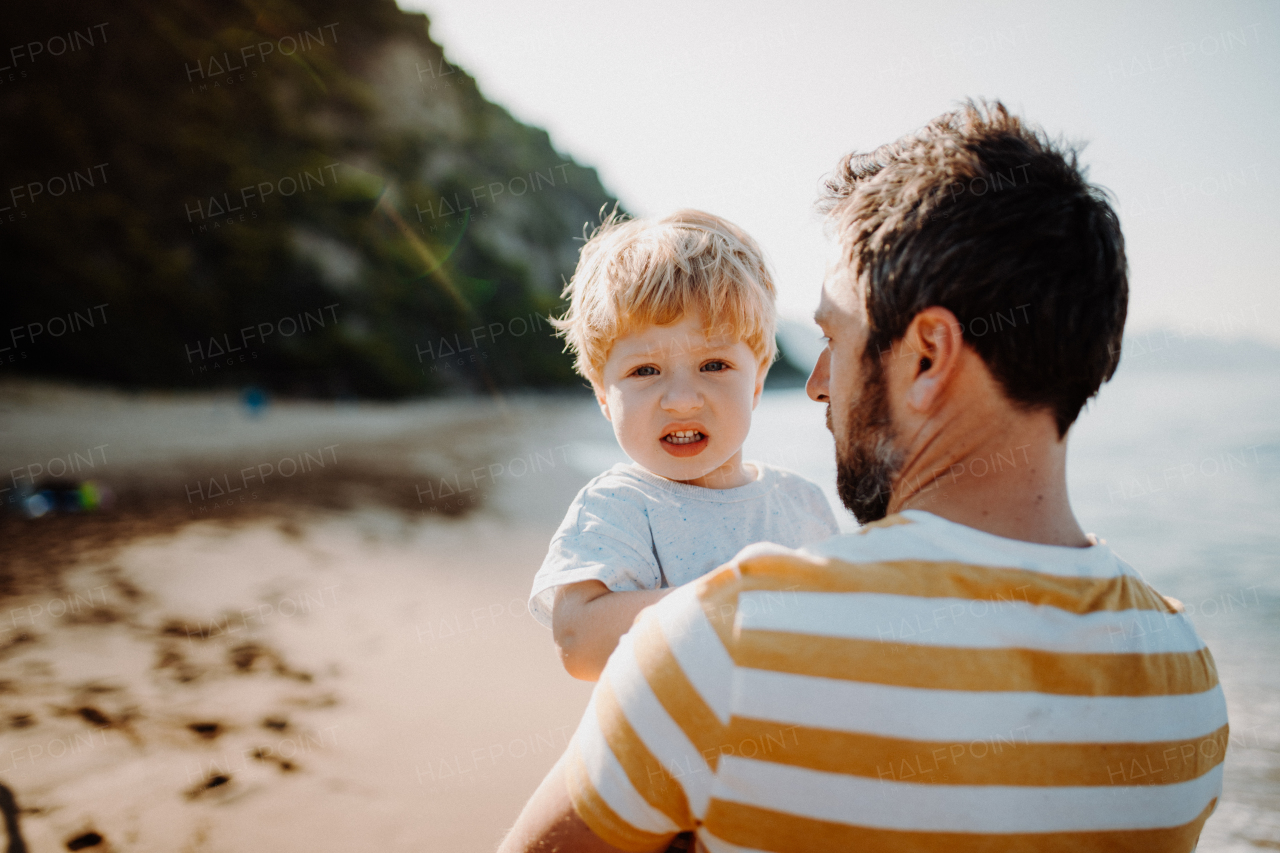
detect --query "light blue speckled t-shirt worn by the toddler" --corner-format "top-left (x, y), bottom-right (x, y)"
top-left (529, 462), bottom-right (838, 628)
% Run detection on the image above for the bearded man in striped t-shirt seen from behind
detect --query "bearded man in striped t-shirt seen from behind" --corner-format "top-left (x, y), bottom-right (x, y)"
top-left (503, 102), bottom-right (1228, 853)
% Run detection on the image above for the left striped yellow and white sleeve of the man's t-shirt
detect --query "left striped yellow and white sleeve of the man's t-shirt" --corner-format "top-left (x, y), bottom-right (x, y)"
top-left (567, 566), bottom-right (735, 850)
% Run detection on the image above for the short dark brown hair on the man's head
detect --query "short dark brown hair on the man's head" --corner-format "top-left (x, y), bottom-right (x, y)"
top-left (819, 101), bottom-right (1129, 437)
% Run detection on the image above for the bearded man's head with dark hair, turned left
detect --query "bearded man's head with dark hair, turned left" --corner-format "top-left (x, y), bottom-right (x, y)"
top-left (810, 102), bottom-right (1128, 521)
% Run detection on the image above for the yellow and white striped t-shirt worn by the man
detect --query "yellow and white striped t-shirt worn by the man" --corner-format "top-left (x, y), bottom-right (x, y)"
top-left (566, 511), bottom-right (1228, 853)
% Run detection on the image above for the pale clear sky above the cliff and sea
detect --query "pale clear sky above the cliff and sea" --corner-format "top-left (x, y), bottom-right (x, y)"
top-left (401, 0), bottom-right (1280, 345)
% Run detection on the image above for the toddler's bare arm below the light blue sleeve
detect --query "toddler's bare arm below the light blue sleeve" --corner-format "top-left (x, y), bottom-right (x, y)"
top-left (552, 580), bottom-right (671, 681)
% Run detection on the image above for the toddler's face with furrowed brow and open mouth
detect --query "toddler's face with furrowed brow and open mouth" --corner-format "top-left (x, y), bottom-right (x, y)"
top-left (595, 316), bottom-right (768, 488)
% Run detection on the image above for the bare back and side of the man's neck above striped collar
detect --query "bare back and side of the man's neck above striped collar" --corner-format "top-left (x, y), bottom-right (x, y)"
top-left (890, 404), bottom-right (1091, 547)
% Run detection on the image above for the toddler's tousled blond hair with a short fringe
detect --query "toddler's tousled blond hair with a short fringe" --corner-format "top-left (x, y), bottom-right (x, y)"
top-left (552, 210), bottom-right (778, 386)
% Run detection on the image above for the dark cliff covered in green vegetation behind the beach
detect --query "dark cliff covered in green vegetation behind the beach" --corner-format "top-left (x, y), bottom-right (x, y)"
top-left (0, 0), bottom-right (614, 397)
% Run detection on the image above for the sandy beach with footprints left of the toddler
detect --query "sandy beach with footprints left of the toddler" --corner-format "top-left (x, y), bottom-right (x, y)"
top-left (0, 384), bottom-right (612, 850)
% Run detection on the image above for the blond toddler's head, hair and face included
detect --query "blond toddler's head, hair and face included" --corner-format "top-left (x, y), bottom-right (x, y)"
top-left (553, 210), bottom-right (777, 487)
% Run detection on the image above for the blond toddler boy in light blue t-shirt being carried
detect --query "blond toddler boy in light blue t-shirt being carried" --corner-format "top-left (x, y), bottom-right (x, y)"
top-left (529, 210), bottom-right (837, 680)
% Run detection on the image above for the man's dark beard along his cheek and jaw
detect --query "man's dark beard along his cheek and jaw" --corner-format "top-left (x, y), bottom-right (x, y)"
top-left (827, 359), bottom-right (902, 524)
